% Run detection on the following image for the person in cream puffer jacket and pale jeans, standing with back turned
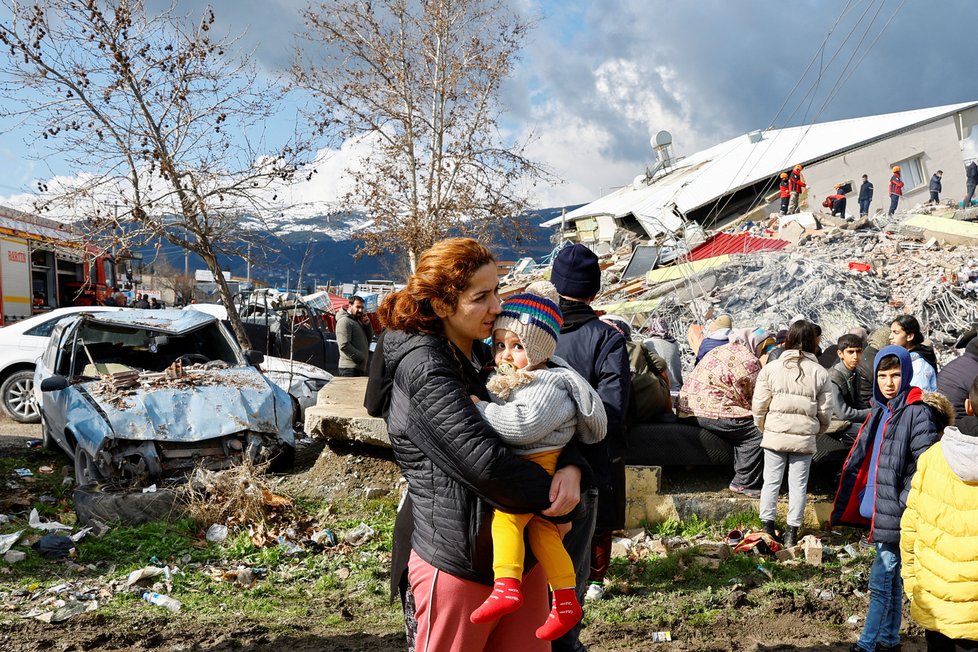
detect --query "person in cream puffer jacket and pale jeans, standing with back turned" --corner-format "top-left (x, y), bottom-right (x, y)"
top-left (751, 321), bottom-right (832, 547)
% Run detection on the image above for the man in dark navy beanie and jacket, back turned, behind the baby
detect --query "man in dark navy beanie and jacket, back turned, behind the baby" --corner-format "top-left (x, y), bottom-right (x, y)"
top-left (550, 244), bottom-right (632, 652)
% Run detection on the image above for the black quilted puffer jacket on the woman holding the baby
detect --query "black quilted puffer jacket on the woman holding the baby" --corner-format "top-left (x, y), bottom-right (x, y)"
top-left (365, 331), bottom-right (586, 585)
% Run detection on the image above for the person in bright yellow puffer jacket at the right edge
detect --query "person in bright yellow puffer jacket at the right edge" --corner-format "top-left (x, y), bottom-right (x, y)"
top-left (900, 378), bottom-right (978, 651)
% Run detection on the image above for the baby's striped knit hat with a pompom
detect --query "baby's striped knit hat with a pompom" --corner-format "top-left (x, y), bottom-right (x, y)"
top-left (493, 281), bottom-right (564, 365)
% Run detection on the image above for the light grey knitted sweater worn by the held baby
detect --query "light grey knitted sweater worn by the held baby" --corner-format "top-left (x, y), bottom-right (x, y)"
top-left (476, 357), bottom-right (608, 455)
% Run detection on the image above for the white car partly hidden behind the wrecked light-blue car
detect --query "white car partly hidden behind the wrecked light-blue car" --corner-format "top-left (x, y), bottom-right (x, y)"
top-left (0, 306), bottom-right (124, 423)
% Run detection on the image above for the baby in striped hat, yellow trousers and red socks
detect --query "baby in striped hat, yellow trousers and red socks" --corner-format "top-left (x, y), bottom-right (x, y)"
top-left (470, 282), bottom-right (607, 641)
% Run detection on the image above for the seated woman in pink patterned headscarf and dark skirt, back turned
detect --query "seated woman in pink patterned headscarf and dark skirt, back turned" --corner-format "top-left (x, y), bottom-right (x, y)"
top-left (676, 328), bottom-right (774, 498)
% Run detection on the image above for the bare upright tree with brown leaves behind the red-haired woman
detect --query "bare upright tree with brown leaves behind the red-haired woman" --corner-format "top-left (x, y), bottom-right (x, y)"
top-left (292, 0), bottom-right (550, 270)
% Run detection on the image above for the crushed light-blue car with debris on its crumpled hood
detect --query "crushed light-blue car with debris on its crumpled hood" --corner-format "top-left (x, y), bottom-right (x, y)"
top-left (34, 310), bottom-right (295, 486)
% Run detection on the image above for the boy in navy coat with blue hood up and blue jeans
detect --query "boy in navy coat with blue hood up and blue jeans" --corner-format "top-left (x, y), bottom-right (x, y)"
top-left (832, 345), bottom-right (953, 652)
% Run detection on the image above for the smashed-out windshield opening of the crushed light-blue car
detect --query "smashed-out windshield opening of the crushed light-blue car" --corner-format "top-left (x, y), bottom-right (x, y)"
top-left (58, 321), bottom-right (241, 378)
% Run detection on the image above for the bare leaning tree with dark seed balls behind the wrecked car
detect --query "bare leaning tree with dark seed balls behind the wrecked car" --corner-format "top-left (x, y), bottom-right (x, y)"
top-left (0, 0), bottom-right (302, 347)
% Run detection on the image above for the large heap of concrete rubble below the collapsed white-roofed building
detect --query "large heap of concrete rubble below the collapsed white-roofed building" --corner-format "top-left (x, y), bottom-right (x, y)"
top-left (500, 205), bottom-right (978, 366)
